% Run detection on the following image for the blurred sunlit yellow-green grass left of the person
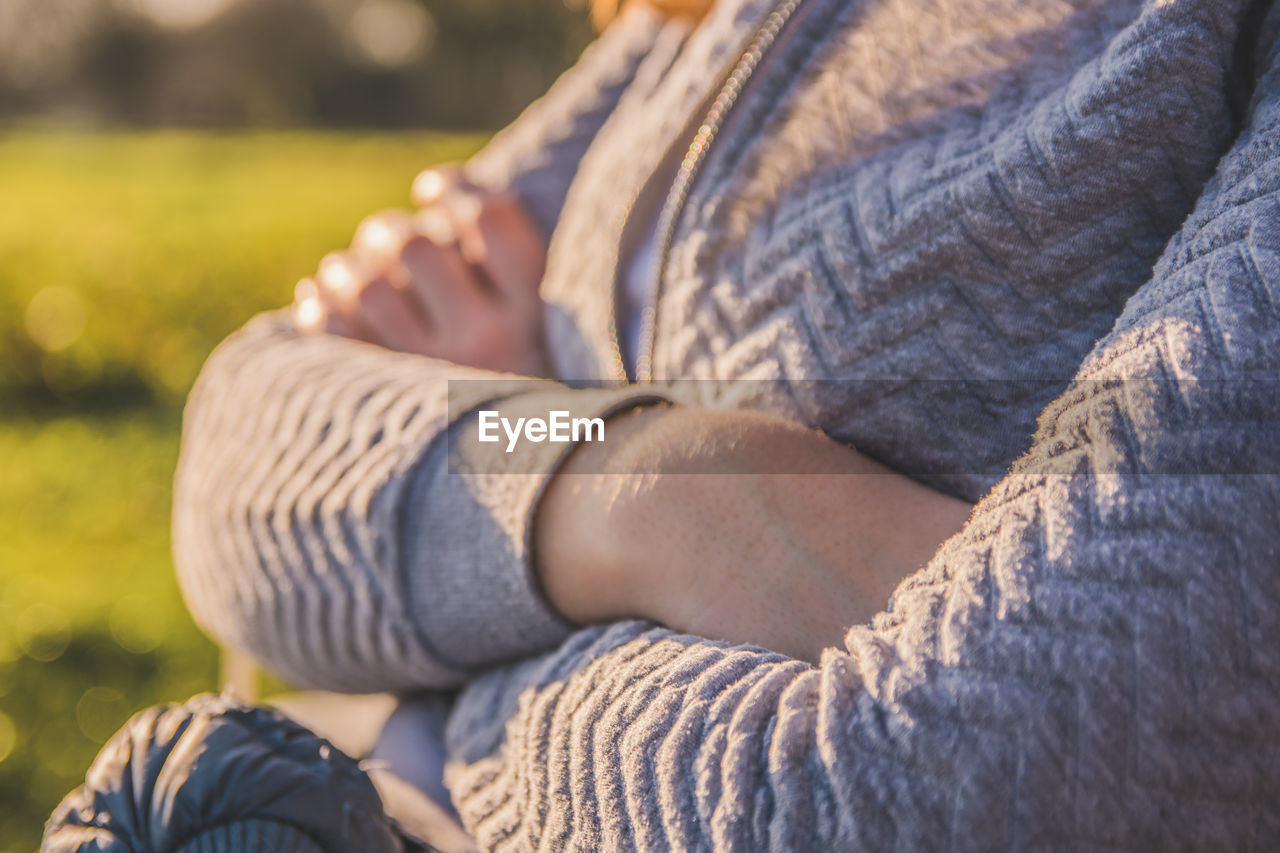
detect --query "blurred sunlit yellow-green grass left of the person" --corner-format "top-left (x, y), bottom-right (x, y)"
top-left (0, 129), bottom-right (483, 853)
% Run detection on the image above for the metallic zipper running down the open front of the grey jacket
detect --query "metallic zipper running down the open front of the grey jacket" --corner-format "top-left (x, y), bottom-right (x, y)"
top-left (609, 0), bottom-right (804, 383)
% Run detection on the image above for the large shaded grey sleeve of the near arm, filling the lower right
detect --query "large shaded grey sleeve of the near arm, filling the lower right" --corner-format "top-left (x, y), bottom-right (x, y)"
top-left (447, 51), bottom-right (1280, 850)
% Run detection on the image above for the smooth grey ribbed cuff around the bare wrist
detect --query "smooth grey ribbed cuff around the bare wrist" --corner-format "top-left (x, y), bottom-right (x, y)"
top-left (402, 383), bottom-right (667, 670)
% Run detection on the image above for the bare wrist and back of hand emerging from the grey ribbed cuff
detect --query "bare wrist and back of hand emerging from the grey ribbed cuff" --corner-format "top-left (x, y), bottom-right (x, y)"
top-left (534, 409), bottom-right (972, 661)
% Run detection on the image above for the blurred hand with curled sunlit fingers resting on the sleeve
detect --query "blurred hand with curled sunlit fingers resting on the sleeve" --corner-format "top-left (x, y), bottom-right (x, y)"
top-left (294, 170), bottom-right (548, 375)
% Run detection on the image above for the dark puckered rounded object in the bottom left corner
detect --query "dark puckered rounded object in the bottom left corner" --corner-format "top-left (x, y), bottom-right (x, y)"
top-left (41, 695), bottom-right (403, 853)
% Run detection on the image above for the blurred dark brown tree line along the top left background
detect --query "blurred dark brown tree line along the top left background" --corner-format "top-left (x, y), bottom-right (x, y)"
top-left (0, 0), bottom-right (591, 128)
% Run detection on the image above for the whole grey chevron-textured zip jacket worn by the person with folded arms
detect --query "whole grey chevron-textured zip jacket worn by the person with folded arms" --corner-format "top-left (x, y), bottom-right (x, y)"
top-left (175, 0), bottom-right (1280, 850)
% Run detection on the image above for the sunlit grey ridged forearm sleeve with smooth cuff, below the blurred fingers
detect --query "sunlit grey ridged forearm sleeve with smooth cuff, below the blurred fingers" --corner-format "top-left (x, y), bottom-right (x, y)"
top-left (173, 313), bottom-right (670, 692)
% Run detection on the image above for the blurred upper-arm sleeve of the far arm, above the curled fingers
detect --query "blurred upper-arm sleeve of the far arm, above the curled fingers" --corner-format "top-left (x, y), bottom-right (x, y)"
top-left (466, 3), bottom-right (684, 234)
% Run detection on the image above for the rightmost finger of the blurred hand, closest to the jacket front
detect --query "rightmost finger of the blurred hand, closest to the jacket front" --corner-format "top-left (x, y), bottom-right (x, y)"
top-left (440, 193), bottom-right (547, 305)
